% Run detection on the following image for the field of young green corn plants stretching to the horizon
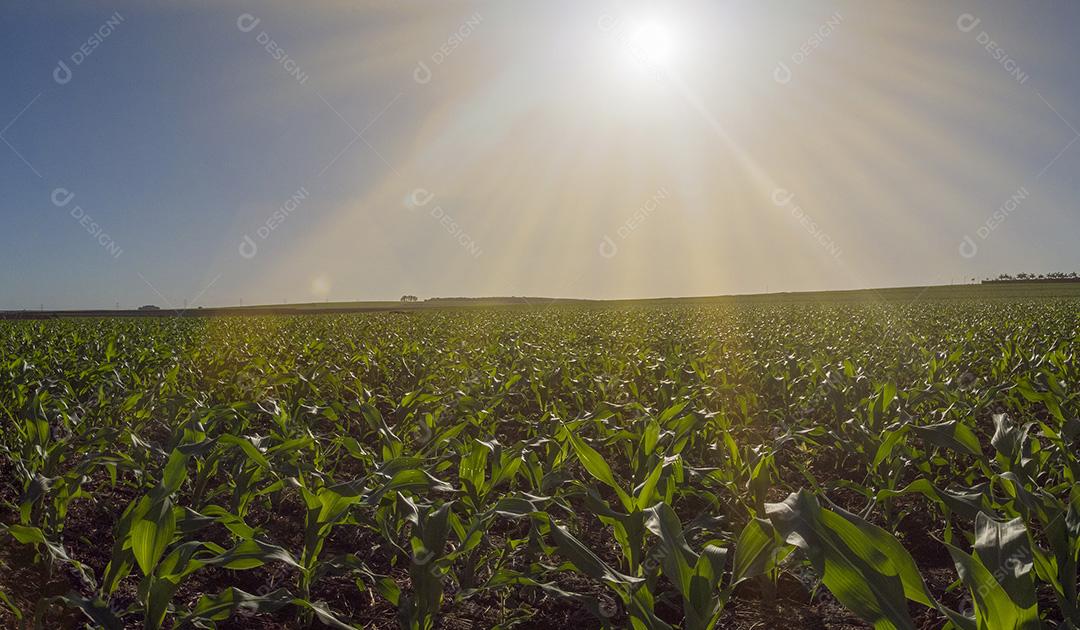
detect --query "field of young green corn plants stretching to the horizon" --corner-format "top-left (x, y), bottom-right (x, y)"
top-left (0, 299), bottom-right (1080, 630)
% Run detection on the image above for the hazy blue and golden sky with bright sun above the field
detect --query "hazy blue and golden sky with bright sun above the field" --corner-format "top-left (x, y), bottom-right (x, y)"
top-left (0, 0), bottom-right (1080, 309)
